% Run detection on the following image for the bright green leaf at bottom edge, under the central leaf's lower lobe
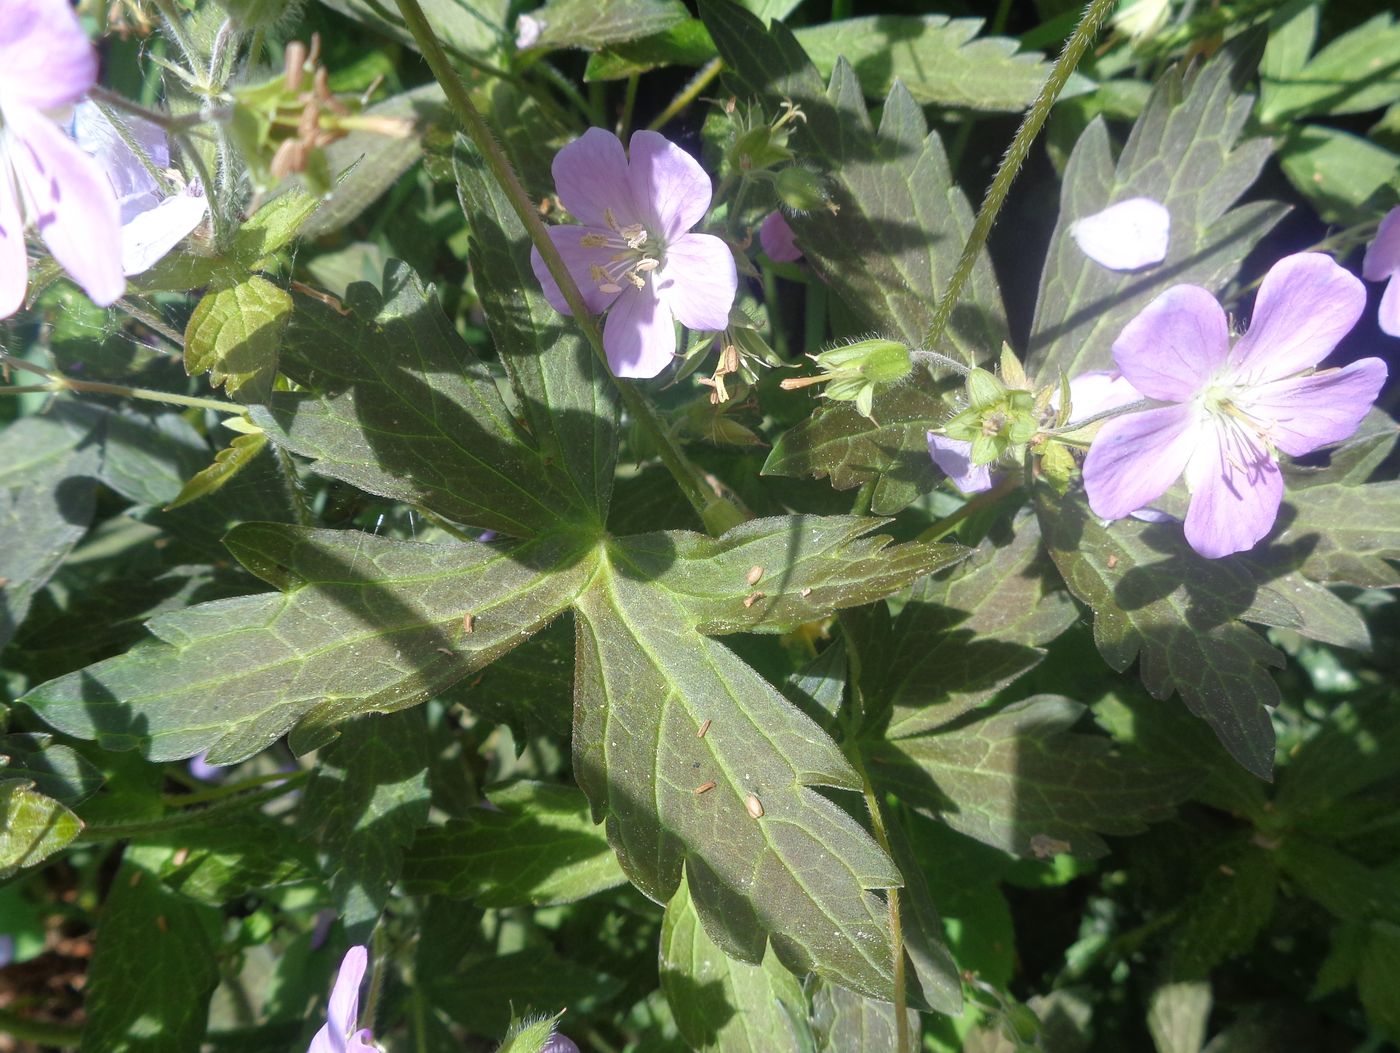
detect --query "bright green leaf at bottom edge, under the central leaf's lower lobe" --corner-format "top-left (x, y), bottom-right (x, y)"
top-left (661, 881), bottom-right (806, 1053)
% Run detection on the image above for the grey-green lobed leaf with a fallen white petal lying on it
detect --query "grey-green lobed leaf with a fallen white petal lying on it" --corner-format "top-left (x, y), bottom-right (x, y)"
top-left (1026, 43), bottom-right (1285, 379)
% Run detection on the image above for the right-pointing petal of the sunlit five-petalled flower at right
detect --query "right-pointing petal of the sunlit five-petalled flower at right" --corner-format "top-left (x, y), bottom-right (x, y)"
top-left (1239, 358), bottom-right (1386, 456)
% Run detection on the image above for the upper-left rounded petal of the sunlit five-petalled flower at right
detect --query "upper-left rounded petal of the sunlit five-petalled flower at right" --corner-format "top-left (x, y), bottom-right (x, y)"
top-left (1113, 286), bottom-right (1229, 402)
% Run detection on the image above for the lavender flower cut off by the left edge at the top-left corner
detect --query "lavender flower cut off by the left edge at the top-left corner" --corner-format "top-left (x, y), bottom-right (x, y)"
top-left (0, 0), bottom-right (126, 318)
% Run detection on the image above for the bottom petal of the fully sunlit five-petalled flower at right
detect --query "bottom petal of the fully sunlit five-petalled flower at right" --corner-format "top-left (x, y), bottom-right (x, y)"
top-left (1184, 426), bottom-right (1284, 559)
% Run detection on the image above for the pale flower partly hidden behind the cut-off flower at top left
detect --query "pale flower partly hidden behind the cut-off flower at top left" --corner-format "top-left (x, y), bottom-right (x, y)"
top-left (73, 102), bottom-right (209, 277)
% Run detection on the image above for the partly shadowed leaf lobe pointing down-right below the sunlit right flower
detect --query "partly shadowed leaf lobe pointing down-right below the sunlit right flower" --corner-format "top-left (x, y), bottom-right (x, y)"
top-left (1036, 487), bottom-right (1282, 779)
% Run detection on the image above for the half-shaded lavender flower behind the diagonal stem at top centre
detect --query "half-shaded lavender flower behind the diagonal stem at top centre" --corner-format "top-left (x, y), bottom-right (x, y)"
top-left (531, 127), bottom-right (739, 377)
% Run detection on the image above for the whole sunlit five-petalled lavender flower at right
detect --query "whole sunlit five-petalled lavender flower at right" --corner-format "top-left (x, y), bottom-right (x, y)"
top-left (1084, 252), bottom-right (1386, 559)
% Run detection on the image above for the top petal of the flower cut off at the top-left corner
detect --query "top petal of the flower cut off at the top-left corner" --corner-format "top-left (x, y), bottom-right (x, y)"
top-left (0, 0), bottom-right (98, 112)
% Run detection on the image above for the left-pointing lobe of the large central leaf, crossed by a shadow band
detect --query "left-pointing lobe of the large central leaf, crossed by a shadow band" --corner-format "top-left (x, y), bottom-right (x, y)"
top-left (24, 524), bottom-right (588, 763)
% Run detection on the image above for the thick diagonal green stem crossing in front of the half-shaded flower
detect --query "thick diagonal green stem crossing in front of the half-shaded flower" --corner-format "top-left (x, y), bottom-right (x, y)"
top-left (396, 0), bottom-right (721, 521)
